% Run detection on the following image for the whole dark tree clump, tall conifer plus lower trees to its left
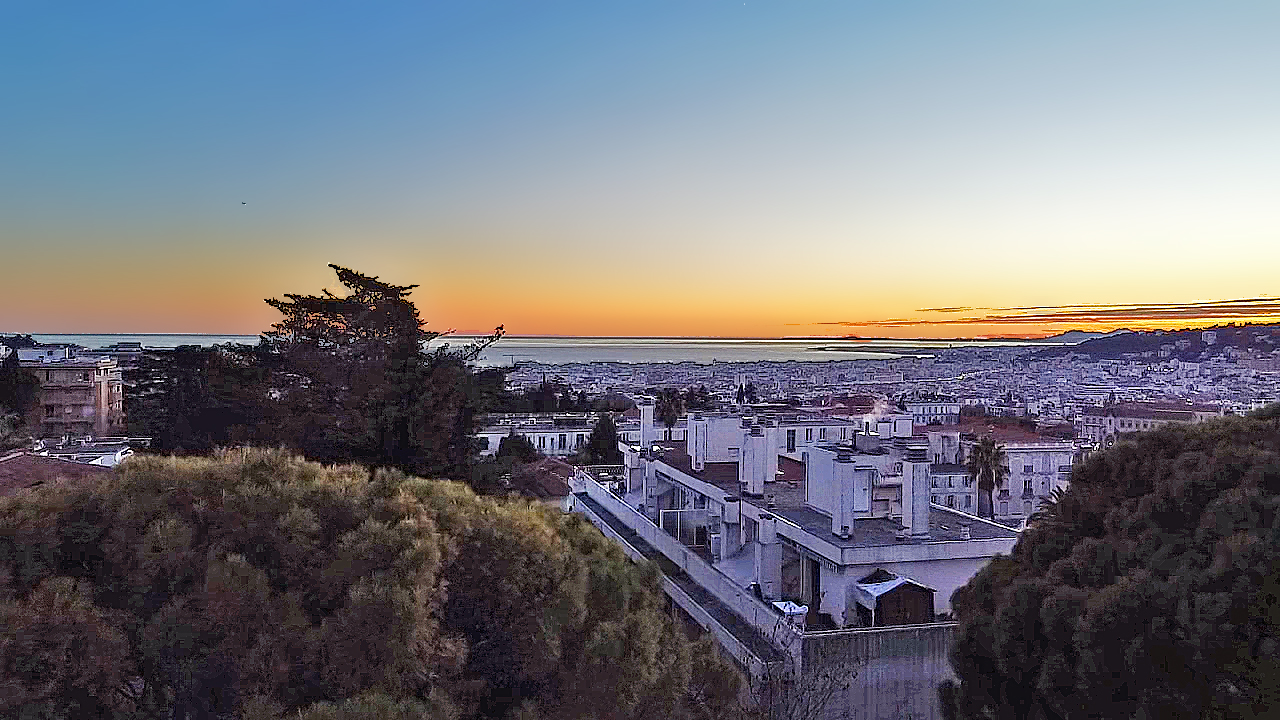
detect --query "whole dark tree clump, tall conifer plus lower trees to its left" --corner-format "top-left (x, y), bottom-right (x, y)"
top-left (127, 265), bottom-right (503, 479)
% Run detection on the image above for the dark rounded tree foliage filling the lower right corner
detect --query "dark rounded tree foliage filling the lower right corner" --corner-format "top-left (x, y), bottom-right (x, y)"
top-left (942, 415), bottom-right (1280, 719)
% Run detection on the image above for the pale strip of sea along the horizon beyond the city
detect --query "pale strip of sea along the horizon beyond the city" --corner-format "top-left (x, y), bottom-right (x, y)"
top-left (20, 333), bottom-right (1059, 366)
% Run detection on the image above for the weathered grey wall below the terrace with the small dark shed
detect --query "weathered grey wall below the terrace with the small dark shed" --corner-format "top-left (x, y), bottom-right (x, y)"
top-left (801, 623), bottom-right (955, 720)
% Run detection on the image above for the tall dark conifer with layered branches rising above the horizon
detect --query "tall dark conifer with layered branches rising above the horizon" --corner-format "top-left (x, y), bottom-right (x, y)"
top-left (262, 265), bottom-right (503, 478)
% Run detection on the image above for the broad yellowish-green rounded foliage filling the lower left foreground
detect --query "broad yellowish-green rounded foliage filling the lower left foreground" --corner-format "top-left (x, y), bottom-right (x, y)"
top-left (0, 451), bottom-right (740, 720)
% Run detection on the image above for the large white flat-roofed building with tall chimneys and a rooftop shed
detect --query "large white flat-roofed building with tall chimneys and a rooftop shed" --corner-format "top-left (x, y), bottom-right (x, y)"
top-left (570, 404), bottom-right (1019, 717)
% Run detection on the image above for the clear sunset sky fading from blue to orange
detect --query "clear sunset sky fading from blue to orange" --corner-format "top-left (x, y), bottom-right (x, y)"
top-left (0, 0), bottom-right (1280, 337)
